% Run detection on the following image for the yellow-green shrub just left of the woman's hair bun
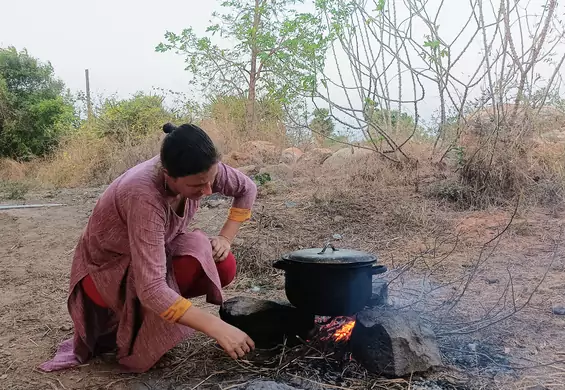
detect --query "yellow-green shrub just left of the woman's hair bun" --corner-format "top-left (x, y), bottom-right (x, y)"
top-left (94, 93), bottom-right (175, 143)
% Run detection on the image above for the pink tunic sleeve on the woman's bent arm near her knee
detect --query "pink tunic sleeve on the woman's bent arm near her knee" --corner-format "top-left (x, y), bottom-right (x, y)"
top-left (212, 163), bottom-right (257, 209)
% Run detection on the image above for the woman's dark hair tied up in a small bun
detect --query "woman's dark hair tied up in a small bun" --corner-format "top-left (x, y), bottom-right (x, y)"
top-left (161, 123), bottom-right (220, 178)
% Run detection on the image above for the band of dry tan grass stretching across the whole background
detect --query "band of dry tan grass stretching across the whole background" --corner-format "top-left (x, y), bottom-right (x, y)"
top-left (0, 102), bottom-right (565, 215)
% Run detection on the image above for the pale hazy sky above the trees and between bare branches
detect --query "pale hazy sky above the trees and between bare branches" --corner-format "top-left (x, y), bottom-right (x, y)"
top-left (0, 0), bottom-right (565, 131)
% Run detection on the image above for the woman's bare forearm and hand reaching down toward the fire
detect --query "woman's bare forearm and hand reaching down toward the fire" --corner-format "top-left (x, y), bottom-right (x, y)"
top-left (179, 306), bottom-right (255, 359)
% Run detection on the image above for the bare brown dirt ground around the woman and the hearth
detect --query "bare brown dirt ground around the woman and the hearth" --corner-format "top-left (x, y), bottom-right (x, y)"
top-left (0, 183), bottom-right (565, 389)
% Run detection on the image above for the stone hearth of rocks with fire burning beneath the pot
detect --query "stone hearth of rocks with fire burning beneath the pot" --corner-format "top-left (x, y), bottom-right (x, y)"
top-left (220, 281), bottom-right (441, 378)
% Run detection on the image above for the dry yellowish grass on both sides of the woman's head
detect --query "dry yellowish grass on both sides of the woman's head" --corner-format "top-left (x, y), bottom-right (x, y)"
top-left (0, 107), bottom-right (288, 188)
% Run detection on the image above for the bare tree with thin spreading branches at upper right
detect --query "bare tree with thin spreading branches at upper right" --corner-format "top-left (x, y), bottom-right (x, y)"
top-left (308, 0), bottom-right (565, 161)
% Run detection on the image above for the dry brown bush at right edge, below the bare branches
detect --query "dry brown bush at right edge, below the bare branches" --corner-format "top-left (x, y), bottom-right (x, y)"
top-left (457, 112), bottom-right (565, 208)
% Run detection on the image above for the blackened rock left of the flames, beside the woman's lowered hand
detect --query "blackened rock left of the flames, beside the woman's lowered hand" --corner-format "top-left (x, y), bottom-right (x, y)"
top-left (220, 297), bottom-right (315, 348)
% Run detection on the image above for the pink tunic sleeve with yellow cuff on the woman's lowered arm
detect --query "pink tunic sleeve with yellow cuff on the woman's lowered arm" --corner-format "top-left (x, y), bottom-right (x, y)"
top-left (126, 195), bottom-right (181, 315)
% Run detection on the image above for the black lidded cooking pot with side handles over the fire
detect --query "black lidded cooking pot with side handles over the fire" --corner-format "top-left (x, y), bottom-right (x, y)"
top-left (273, 244), bottom-right (387, 317)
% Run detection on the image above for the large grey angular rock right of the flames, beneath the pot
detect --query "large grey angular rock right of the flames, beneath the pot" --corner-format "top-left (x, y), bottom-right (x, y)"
top-left (350, 307), bottom-right (441, 377)
